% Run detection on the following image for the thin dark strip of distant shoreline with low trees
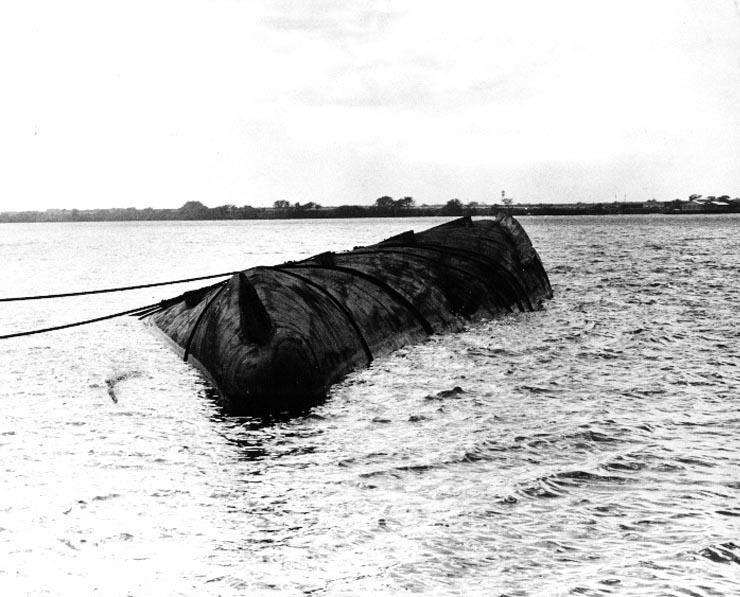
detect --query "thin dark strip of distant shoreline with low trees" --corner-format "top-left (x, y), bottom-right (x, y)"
top-left (0, 196), bottom-right (740, 224)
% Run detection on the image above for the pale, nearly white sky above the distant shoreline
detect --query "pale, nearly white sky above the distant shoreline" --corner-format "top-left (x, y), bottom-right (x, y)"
top-left (0, 0), bottom-right (740, 211)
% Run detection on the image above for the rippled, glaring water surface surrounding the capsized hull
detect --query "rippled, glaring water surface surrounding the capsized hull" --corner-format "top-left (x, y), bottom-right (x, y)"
top-left (0, 216), bottom-right (740, 596)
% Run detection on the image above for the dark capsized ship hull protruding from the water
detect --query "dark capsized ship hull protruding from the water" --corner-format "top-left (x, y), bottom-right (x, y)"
top-left (148, 214), bottom-right (552, 412)
